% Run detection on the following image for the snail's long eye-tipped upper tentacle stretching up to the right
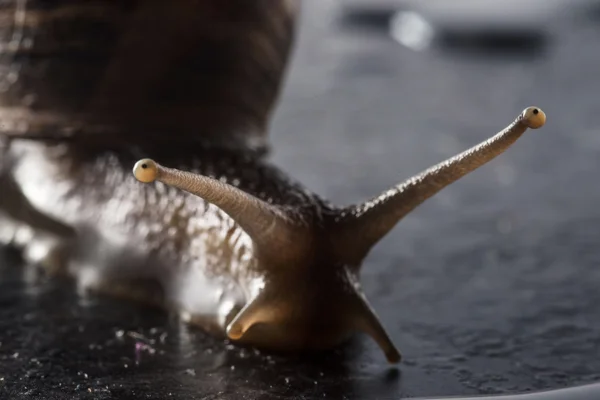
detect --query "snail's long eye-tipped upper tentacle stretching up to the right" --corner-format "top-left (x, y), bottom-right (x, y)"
top-left (332, 107), bottom-right (546, 262)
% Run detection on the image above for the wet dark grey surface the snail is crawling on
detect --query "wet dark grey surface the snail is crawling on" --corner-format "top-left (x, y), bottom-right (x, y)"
top-left (0, 1), bottom-right (600, 399)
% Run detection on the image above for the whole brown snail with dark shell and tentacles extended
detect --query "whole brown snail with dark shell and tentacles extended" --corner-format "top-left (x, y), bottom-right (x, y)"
top-left (0, 0), bottom-right (546, 363)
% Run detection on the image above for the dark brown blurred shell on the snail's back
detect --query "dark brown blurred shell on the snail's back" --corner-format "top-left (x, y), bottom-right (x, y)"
top-left (0, 0), bottom-right (298, 147)
